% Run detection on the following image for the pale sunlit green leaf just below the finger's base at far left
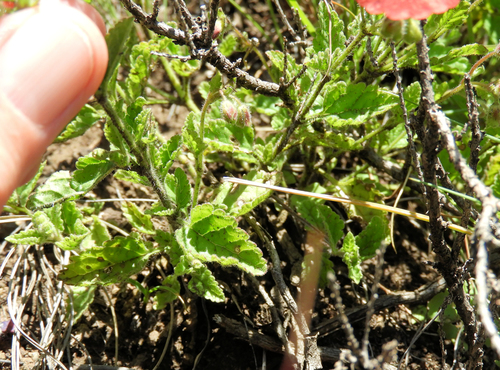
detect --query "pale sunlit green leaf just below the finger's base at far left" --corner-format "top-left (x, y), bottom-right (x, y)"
top-left (27, 171), bottom-right (82, 209)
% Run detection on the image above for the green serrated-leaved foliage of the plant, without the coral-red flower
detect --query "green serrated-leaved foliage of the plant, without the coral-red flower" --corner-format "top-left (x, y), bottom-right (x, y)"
top-left (2, 0), bottom-right (500, 368)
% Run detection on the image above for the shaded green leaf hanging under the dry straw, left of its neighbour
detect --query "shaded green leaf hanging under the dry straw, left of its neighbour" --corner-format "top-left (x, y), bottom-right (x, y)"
top-left (290, 191), bottom-right (344, 255)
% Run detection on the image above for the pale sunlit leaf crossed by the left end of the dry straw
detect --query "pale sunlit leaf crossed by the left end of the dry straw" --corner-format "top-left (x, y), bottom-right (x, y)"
top-left (213, 170), bottom-right (277, 217)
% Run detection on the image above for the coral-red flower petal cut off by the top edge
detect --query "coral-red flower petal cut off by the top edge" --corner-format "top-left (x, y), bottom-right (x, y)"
top-left (356, 0), bottom-right (460, 21)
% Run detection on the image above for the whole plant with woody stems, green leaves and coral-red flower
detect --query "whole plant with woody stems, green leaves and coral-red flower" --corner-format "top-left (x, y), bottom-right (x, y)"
top-left (5, 0), bottom-right (500, 368)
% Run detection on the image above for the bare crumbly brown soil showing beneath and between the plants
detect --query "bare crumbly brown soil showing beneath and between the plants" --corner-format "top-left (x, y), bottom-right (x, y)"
top-left (0, 2), bottom-right (494, 370)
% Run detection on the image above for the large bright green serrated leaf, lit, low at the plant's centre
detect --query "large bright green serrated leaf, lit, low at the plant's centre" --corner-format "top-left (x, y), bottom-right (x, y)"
top-left (175, 203), bottom-right (266, 275)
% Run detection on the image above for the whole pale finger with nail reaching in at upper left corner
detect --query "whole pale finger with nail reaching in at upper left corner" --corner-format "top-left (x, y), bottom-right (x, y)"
top-left (0, 0), bottom-right (108, 210)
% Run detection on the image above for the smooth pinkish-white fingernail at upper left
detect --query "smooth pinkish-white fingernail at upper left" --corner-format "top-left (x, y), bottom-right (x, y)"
top-left (0, 13), bottom-right (94, 126)
